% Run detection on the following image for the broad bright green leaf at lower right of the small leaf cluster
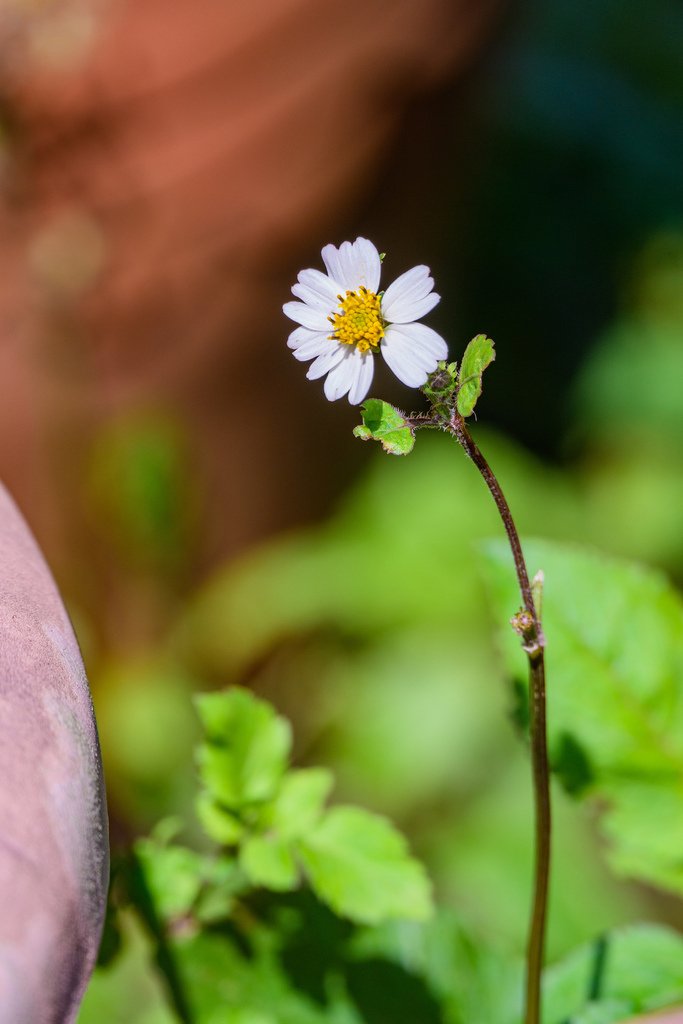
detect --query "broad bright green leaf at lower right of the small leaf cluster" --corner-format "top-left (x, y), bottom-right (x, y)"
top-left (297, 807), bottom-right (432, 924)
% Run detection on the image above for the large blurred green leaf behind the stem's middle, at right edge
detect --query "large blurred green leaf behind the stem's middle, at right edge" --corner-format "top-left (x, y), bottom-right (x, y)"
top-left (486, 542), bottom-right (683, 893)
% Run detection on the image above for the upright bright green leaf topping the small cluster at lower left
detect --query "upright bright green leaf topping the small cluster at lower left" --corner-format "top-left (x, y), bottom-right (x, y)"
top-left (197, 687), bottom-right (292, 810)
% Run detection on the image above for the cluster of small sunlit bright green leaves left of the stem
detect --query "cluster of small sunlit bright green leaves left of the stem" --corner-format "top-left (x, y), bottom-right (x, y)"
top-left (192, 688), bottom-right (431, 922)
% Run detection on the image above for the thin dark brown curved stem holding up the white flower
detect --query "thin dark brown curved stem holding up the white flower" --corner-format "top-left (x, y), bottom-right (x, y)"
top-left (447, 411), bottom-right (551, 1024)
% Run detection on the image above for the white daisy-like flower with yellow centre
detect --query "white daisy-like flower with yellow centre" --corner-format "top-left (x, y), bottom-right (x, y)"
top-left (283, 239), bottom-right (447, 406)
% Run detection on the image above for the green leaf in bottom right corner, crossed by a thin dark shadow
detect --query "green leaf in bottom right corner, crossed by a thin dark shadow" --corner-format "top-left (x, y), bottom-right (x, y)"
top-left (544, 925), bottom-right (683, 1024)
